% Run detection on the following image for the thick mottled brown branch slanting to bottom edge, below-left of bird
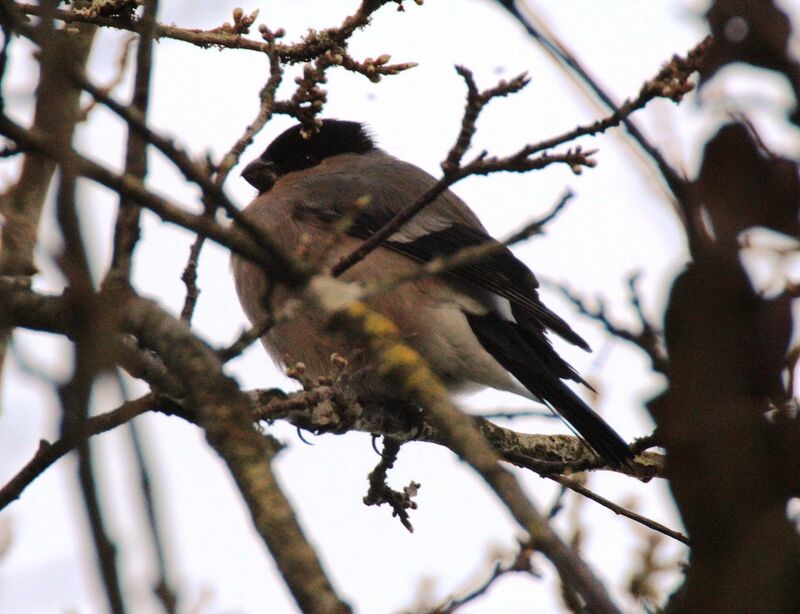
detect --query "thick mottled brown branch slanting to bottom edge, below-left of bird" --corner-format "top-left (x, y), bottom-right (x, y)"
top-left (125, 299), bottom-right (350, 612)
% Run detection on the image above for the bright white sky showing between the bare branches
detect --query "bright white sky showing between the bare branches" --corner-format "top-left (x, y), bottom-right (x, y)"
top-left (0, 0), bottom-right (797, 613)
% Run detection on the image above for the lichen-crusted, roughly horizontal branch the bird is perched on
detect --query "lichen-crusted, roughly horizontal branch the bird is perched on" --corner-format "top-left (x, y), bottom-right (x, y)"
top-left (0, 278), bottom-right (663, 490)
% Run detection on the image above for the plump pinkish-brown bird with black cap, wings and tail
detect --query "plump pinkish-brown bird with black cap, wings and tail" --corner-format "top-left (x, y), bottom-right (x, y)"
top-left (231, 119), bottom-right (633, 466)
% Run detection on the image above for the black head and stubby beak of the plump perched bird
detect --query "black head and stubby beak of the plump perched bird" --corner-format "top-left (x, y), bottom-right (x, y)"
top-left (242, 119), bottom-right (375, 193)
